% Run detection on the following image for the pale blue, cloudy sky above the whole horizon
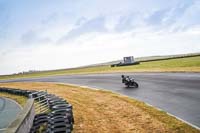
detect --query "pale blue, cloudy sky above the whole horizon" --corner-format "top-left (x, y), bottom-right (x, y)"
top-left (0, 0), bottom-right (200, 75)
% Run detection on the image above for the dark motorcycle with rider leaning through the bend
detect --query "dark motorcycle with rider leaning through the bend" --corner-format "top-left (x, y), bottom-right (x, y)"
top-left (122, 75), bottom-right (139, 88)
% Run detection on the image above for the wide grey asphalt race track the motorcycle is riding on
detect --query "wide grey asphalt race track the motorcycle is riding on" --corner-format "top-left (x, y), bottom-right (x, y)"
top-left (0, 73), bottom-right (200, 127)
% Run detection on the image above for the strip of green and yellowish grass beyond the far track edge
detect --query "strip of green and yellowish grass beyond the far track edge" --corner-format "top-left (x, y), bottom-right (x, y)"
top-left (0, 56), bottom-right (200, 80)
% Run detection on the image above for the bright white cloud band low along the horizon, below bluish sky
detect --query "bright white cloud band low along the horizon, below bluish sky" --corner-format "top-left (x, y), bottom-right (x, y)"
top-left (0, 27), bottom-right (200, 74)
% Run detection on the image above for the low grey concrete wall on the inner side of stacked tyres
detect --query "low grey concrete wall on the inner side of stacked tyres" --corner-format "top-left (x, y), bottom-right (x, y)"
top-left (5, 99), bottom-right (35, 133)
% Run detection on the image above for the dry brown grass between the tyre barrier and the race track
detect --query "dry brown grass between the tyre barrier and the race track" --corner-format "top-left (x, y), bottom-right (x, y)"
top-left (0, 83), bottom-right (200, 133)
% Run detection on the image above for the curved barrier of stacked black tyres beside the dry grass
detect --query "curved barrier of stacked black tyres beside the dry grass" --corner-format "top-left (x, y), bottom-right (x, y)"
top-left (0, 88), bottom-right (74, 133)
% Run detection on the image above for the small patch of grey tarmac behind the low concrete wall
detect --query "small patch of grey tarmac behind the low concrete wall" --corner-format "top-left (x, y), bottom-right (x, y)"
top-left (0, 97), bottom-right (21, 133)
